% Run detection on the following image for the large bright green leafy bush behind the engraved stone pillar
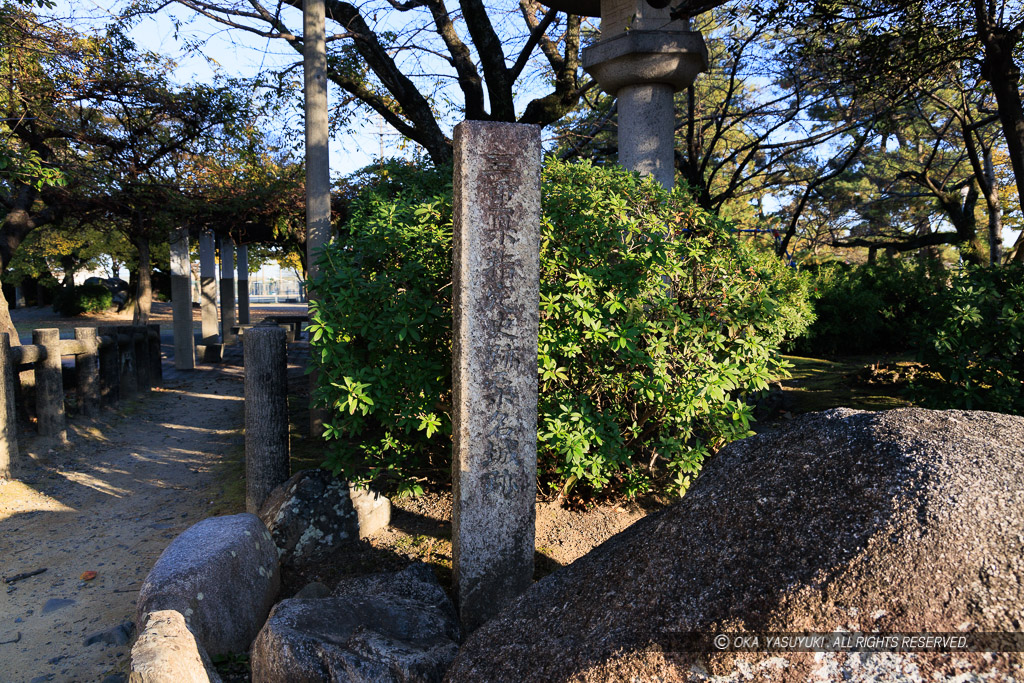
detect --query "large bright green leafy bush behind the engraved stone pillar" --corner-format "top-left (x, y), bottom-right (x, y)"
top-left (311, 163), bottom-right (810, 495)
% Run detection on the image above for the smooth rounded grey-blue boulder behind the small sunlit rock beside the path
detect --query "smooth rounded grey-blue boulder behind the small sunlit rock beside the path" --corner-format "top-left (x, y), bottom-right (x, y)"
top-left (136, 514), bottom-right (281, 655)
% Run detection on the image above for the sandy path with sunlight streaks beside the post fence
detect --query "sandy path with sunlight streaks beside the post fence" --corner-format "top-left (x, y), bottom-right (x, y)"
top-left (0, 356), bottom-right (243, 683)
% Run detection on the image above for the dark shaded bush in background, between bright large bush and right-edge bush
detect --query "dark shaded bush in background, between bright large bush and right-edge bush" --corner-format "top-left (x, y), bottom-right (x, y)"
top-left (793, 258), bottom-right (947, 356)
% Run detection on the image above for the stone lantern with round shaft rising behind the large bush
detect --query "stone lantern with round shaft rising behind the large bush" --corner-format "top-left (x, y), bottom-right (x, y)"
top-left (541, 0), bottom-right (708, 188)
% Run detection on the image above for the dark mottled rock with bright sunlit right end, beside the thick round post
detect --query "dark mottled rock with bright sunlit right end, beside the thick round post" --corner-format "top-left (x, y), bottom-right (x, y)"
top-left (259, 469), bottom-right (391, 564)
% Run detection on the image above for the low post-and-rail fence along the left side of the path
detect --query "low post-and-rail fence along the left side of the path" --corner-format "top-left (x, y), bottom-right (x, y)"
top-left (0, 325), bottom-right (164, 477)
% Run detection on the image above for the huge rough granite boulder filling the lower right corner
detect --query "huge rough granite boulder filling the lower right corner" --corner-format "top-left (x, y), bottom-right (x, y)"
top-left (447, 409), bottom-right (1024, 681)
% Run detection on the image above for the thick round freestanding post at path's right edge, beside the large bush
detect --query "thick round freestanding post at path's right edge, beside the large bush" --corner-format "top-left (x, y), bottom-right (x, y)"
top-left (242, 326), bottom-right (290, 514)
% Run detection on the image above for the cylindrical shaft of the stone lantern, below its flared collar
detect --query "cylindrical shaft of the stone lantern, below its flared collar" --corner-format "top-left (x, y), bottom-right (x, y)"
top-left (618, 83), bottom-right (676, 189)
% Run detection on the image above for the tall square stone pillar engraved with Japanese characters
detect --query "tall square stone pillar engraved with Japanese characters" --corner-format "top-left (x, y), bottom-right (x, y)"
top-left (452, 121), bottom-right (541, 630)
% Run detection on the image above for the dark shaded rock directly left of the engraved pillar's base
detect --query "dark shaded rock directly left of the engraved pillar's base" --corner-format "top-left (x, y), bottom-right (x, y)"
top-left (252, 564), bottom-right (460, 683)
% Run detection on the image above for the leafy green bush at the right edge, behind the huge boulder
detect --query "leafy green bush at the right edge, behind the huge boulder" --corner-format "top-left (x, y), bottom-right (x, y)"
top-left (913, 264), bottom-right (1024, 415)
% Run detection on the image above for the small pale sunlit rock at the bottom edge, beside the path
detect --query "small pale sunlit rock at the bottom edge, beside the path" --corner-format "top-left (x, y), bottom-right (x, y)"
top-left (128, 609), bottom-right (220, 683)
